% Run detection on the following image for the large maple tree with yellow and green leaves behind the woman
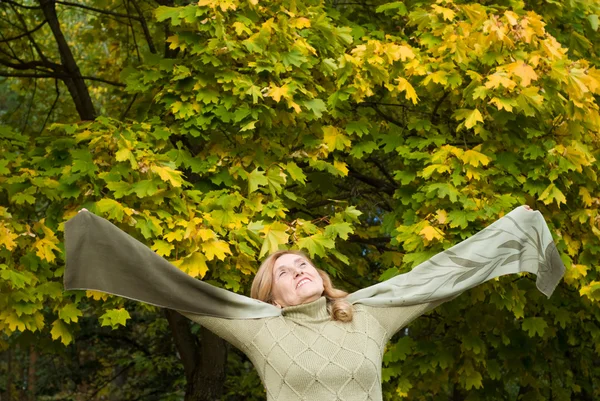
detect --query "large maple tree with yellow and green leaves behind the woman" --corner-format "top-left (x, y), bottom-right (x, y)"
top-left (0, 0), bottom-right (600, 400)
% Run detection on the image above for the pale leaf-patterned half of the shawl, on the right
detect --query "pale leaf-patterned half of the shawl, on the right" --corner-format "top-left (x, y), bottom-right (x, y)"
top-left (348, 207), bottom-right (565, 307)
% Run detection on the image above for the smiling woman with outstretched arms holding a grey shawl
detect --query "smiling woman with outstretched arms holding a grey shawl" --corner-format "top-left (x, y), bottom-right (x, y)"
top-left (65, 207), bottom-right (564, 401)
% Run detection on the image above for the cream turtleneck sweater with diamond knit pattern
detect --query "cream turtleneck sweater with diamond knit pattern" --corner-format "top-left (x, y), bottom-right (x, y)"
top-left (181, 297), bottom-right (439, 401)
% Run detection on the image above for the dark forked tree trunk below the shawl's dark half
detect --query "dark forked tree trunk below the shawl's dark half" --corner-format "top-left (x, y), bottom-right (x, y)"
top-left (165, 309), bottom-right (227, 401)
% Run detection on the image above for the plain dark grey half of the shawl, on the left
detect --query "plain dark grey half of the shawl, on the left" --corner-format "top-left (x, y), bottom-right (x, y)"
top-left (64, 211), bottom-right (281, 319)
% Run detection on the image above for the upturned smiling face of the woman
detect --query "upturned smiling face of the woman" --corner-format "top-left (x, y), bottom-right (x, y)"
top-left (271, 253), bottom-right (324, 308)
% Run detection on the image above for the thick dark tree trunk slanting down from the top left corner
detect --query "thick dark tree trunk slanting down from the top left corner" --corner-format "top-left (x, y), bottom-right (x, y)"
top-left (38, 0), bottom-right (96, 120)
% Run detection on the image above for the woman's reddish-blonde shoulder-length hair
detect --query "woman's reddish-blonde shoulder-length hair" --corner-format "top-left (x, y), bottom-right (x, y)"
top-left (250, 251), bottom-right (353, 322)
